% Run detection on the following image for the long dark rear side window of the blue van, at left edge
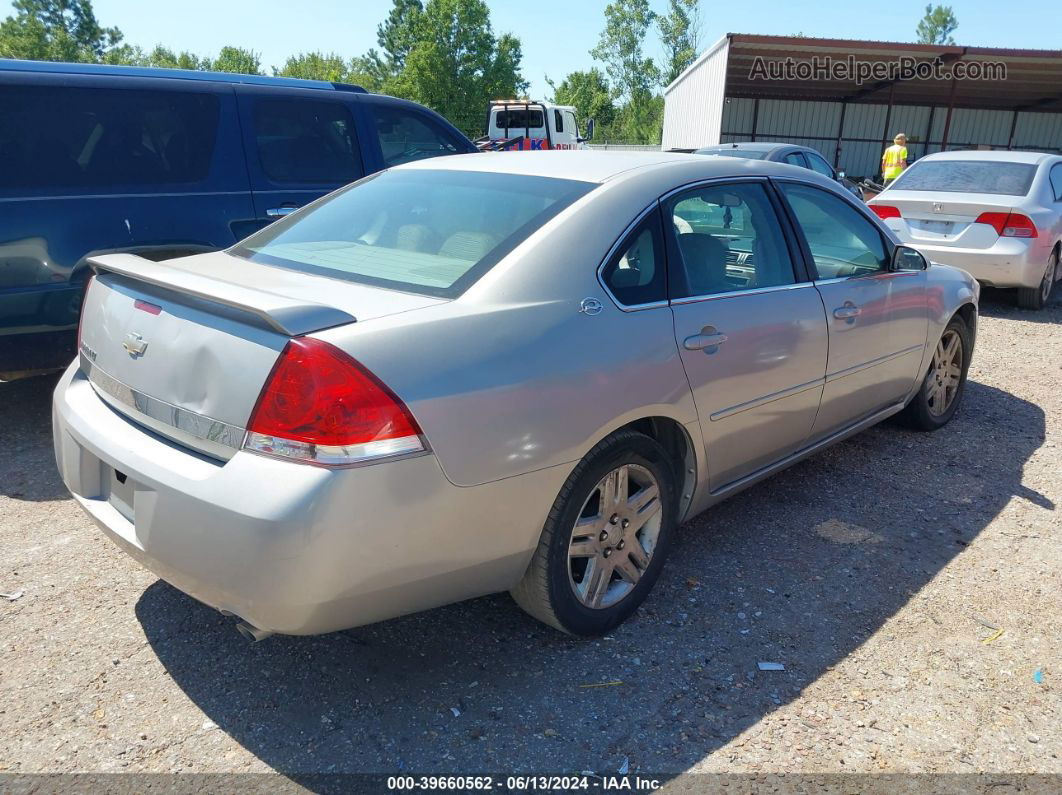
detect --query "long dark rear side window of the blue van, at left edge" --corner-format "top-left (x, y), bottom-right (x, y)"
top-left (0, 85), bottom-right (220, 192)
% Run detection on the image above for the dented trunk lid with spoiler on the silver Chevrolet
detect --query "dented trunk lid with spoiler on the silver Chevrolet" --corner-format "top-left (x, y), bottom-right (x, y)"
top-left (81, 253), bottom-right (441, 459)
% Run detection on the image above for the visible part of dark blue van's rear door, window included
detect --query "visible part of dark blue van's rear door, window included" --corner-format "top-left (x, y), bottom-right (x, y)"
top-left (237, 85), bottom-right (365, 226)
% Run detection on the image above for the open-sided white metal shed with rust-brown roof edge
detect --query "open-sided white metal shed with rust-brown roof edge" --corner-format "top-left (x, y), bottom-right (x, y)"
top-left (663, 33), bottom-right (1062, 176)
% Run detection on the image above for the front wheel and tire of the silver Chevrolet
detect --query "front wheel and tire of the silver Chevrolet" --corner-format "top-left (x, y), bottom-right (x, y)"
top-left (900, 315), bottom-right (974, 431)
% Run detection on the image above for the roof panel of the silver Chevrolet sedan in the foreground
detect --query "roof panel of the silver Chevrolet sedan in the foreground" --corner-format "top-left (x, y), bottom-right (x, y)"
top-left (395, 150), bottom-right (830, 184)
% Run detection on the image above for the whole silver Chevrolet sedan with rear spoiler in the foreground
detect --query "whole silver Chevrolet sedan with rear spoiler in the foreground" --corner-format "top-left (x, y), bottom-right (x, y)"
top-left (54, 152), bottom-right (978, 638)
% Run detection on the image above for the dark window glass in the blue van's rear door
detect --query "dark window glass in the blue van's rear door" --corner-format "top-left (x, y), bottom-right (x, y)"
top-left (253, 99), bottom-right (363, 185)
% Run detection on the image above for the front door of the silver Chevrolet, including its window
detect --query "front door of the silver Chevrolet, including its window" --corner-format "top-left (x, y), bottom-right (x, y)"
top-left (777, 180), bottom-right (928, 440)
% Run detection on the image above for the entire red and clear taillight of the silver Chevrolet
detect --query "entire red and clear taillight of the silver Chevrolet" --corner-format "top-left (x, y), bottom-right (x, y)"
top-left (243, 336), bottom-right (425, 466)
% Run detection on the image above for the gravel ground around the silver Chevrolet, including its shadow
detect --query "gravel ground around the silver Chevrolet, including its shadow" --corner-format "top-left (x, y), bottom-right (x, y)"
top-left (0, 292), bottom-right (1062, 781)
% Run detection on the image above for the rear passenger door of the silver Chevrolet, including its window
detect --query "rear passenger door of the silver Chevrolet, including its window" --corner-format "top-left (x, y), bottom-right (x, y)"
top-left (663, 179), bottom-right (826, 491)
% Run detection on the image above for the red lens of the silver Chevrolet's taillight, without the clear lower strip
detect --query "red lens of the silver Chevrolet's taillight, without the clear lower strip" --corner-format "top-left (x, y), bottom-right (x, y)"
top-left (247, 338), bottom-right (421, 447)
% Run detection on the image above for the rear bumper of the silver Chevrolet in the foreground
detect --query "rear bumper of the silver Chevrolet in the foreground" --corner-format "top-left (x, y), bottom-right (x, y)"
top-left (53, 365), bottom-right (566, 635)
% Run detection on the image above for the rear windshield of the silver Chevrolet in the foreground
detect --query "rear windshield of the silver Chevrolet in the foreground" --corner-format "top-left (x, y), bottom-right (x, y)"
top-left (232, 170), bottom-right (595, 297)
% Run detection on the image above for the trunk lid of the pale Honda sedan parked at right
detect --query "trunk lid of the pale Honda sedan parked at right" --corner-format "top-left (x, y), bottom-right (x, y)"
top-left (872, 190), bottom-right (1014, 248)
